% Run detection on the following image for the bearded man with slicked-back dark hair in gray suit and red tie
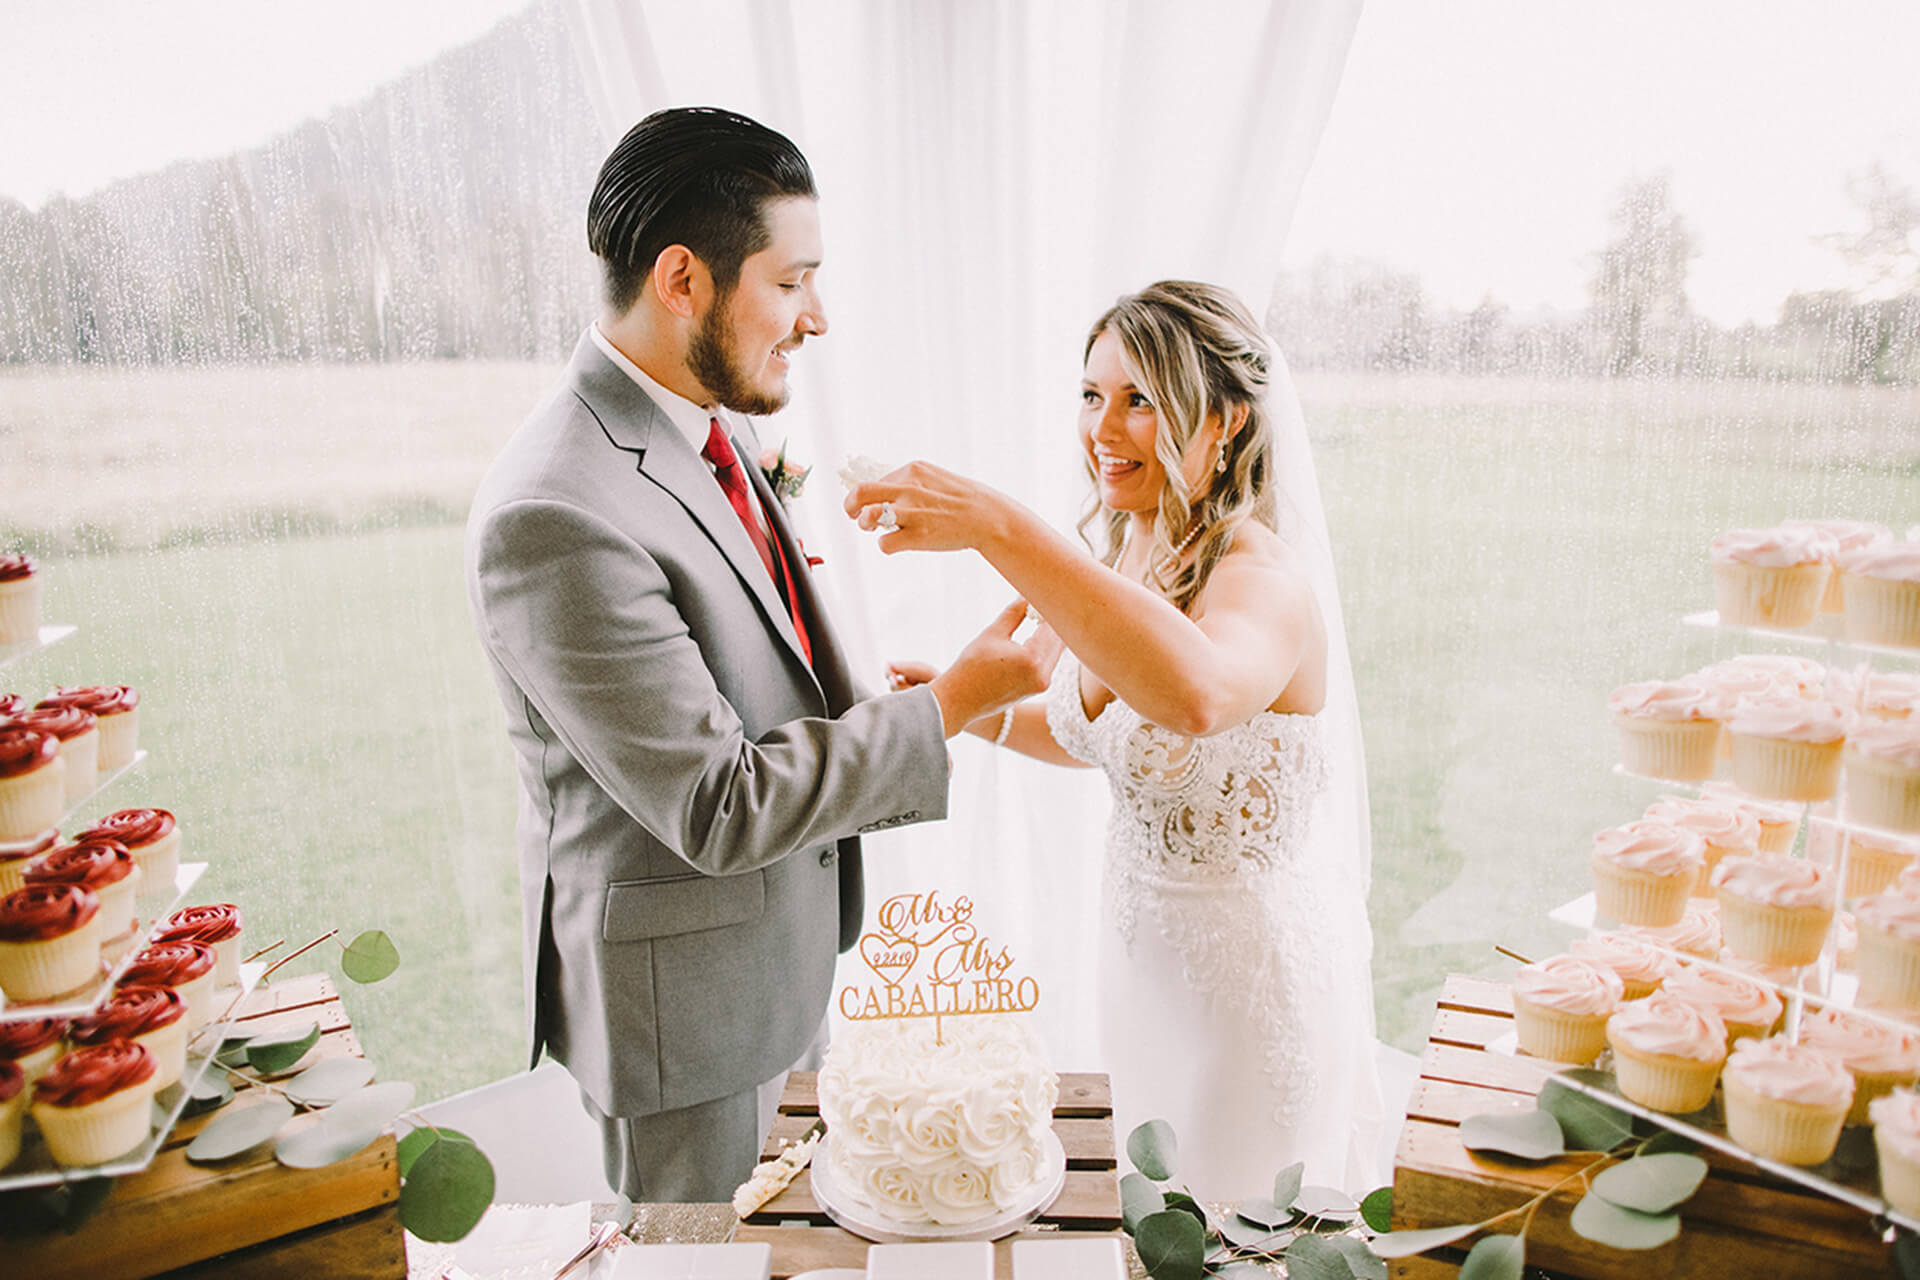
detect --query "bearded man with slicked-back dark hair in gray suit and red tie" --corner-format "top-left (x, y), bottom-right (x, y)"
top-left (467, 109), bottom-right (1050, 1201)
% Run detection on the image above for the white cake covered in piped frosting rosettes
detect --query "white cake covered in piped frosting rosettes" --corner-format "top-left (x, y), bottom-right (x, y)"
top-left (816, 1015), bottom-right (1066, 1238)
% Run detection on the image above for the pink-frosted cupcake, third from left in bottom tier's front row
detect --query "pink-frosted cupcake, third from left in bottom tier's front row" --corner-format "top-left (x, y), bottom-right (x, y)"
top-left (1724, 1036), bottom-right (1853, 1165)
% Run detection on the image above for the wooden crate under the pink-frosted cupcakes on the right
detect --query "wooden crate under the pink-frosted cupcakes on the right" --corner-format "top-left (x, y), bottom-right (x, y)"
top-left (1390, 975), bottom-right (1895, 1280)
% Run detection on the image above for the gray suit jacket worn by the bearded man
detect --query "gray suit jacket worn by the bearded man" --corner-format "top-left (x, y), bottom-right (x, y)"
top-left (467, 336), bottom-right (948, 1115)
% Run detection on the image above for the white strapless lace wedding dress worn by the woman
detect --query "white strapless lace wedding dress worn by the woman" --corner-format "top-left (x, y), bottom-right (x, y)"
top-left (1046, 654), bottom-right (1382, 1201)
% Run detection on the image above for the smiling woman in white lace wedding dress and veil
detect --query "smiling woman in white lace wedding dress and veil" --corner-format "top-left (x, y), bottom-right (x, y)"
top-left (847, 280), bottom-right (1380, 1199)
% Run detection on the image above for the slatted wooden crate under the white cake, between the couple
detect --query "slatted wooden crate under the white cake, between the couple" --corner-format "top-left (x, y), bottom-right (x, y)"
top-left (733, 1071), bottom-right (1119, 1280)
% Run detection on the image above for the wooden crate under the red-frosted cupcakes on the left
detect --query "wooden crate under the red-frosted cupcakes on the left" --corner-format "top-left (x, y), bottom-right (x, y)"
top-left (0, 973), bottom-right (407, 1280)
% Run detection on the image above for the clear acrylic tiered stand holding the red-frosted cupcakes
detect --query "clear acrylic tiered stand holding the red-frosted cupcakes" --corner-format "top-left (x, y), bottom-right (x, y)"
top-left (0, 626), bottom-right (267, 1192)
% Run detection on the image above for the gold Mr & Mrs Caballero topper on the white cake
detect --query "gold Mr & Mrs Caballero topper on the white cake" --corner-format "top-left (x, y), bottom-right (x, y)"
top-left (839, 890), bottom-right (1041, 1034)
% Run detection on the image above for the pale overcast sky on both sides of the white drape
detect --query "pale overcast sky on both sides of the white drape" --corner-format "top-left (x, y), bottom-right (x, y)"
top-left (0, 0), bottom-right (1920, 324)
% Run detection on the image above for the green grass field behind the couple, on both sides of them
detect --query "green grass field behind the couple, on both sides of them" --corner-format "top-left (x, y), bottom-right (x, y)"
top-left (0, 365), bottom-right (1920, 1098)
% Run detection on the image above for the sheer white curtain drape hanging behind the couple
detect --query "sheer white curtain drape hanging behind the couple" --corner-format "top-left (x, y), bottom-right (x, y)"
top-left (566, 0), bottom-right (1365, 1069)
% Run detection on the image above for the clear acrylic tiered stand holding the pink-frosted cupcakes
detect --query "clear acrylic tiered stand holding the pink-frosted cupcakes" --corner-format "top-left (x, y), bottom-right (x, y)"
top-left (1512, 610), bottom-right (1920, 1232)
